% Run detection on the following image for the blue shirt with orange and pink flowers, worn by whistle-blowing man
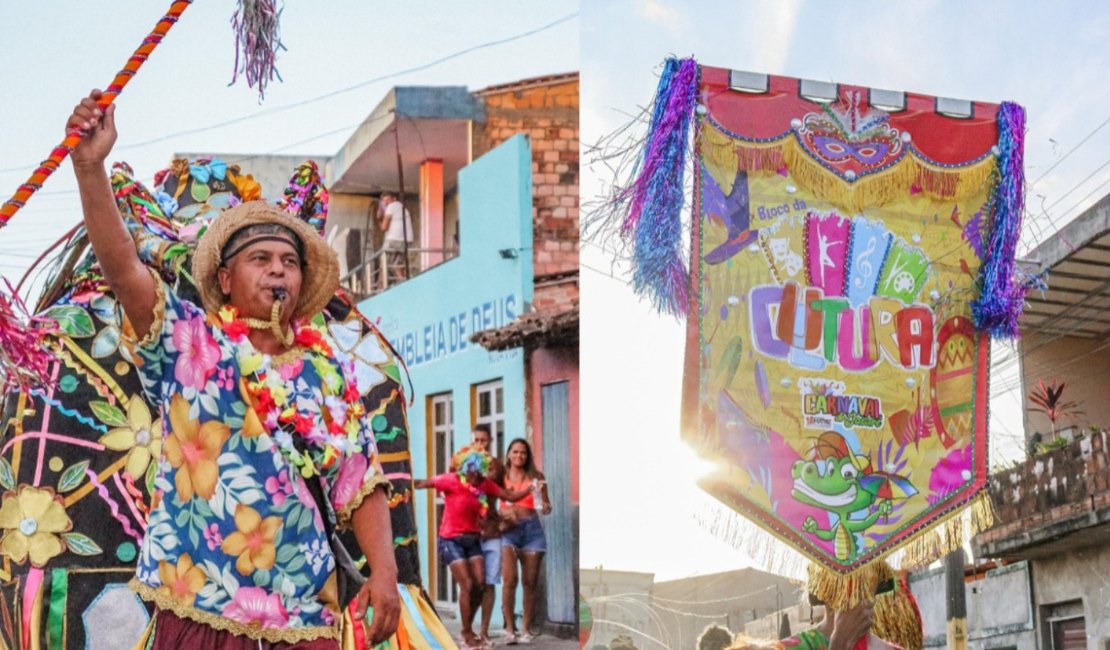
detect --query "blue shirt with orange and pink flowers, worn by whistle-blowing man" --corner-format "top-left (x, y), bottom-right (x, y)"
top-left (133, 281), bottom-right (389, 642)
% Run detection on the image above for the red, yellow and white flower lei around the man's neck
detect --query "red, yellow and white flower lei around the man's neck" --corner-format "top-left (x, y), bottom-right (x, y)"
top-left (218, 305), bottom-right (366, 478)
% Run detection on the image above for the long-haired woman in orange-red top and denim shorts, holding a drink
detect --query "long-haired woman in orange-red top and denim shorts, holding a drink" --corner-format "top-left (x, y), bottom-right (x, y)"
top-left (501, 438), bottom-right (552, 646)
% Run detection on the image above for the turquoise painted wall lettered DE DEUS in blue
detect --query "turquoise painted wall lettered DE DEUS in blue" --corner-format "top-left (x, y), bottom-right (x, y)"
top-left (359, 135), bottom-right (533, 594)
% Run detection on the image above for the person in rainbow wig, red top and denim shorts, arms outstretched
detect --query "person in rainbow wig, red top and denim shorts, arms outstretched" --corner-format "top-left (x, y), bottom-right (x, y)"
top-left (413, 447), bottom-right (528, 650)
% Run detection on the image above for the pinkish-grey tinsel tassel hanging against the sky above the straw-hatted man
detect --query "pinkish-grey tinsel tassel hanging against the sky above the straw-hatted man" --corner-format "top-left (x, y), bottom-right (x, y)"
top-left (231, 0), bottom-right (285, 102)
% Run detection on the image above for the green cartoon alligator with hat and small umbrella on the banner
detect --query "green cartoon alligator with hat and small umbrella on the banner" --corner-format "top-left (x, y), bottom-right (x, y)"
top-left (791, 431), bottom-right (892, 562)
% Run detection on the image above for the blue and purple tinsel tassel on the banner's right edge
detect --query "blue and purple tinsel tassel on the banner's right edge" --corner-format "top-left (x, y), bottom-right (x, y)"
top-left (971, 102), bottom-right (1030, 338)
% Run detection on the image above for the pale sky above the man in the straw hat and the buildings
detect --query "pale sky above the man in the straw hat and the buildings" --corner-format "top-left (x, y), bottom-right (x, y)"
top-left (0, 0), bottom-right (578, 282)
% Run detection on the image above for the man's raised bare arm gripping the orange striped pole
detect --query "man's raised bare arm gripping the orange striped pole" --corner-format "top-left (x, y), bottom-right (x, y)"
top-left (65, 90), bottom-right (158, 338)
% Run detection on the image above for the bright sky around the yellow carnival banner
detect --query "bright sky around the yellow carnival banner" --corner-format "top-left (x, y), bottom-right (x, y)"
top-left (581, 0), bottom-right (1110, 579)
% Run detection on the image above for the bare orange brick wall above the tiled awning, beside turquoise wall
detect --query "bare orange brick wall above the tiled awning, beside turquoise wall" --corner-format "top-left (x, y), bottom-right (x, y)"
top-left (474, 73), bottom-right (578, 308)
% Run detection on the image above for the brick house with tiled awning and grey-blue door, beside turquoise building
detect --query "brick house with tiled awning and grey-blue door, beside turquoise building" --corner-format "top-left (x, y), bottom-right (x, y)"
top-left (473, 73), bottom-right (578, 634)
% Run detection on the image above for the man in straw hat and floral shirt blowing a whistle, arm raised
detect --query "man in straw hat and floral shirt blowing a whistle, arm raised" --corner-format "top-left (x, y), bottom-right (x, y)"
top-left (67, 91), bottom-right (400, 650)
